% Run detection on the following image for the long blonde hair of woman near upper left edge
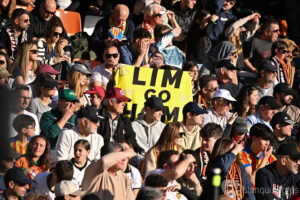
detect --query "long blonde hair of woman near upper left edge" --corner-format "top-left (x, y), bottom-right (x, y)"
top-left (9, 41), bottom-right (37, 82)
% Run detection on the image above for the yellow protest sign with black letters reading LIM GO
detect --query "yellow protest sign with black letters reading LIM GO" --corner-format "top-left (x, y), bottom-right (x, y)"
top-left (115, 65), bottom-right (193, 122)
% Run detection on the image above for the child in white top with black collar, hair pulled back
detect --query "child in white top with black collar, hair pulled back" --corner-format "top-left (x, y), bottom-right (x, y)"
top-left (71, 139), bottom-right (91, 186)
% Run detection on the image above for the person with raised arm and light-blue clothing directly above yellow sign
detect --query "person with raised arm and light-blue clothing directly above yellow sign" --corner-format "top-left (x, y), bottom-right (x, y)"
top-left (154, 11), bottom-right (186, 69)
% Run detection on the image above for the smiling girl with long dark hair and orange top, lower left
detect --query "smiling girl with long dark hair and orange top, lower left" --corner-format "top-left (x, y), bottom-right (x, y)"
top-left (16, 135), bottom-right (51, 179)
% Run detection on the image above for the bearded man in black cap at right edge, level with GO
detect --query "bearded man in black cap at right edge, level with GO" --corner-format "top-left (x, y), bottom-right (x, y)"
top-left (273, 83), bottom-right (300, 127)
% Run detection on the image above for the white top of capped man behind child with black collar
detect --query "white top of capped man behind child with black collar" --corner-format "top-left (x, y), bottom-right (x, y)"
top-left (55, 128), bottom-right (104, 161)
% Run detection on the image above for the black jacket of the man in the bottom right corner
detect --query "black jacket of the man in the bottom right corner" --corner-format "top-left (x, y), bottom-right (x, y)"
top-left (255, 161), bottom-right (300, 200)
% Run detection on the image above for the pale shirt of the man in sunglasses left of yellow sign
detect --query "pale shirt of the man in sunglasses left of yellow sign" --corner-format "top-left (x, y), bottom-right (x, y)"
top-left (91, 64), bottom-right (112, 87)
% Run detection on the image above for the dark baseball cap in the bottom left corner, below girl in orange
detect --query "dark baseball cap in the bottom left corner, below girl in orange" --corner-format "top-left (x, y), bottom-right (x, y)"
top-left (4, 167), bottom-right (32, 185)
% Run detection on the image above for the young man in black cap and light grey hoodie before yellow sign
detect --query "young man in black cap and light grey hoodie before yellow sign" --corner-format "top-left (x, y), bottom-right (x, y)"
top-left (132, 96), bottom-right (166, 159)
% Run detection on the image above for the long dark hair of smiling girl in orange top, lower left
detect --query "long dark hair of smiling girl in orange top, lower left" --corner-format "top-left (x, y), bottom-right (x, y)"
top-left (25, 135), bottom-right (51, 169)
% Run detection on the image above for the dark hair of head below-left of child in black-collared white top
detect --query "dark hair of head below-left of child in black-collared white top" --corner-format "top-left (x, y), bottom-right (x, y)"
top-left (55, 160), bottom-right (74, 182)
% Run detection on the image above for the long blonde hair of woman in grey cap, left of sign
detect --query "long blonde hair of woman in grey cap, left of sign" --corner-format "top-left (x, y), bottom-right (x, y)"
top-left (67, 70), bottom-right (89, 98)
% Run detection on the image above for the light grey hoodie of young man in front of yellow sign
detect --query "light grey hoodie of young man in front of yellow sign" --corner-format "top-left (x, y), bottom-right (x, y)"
top-left (132, 115), bottom-right (166, 157)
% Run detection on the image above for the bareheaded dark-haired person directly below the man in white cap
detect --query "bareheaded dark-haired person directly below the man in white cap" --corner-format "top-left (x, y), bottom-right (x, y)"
top-left (196, 123), bottom-right (223, 181)
